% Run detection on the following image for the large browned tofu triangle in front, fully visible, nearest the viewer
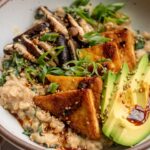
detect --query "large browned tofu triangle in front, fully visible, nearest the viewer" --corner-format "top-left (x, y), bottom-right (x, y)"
top-left (34, 89), bottom-right (100, 140)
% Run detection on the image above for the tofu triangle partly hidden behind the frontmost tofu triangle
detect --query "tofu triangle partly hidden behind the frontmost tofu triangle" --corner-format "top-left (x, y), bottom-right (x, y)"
top-left (47, 75), bottom-right (102, 114)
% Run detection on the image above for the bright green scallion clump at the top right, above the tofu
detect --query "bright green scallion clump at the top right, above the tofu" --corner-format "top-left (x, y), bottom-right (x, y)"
top-left (92, 3), bottom-right (129, 24)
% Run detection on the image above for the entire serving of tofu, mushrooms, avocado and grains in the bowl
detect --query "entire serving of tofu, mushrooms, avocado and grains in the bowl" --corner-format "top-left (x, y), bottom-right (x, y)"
top-left (0, 0), bottom-right (150, 150)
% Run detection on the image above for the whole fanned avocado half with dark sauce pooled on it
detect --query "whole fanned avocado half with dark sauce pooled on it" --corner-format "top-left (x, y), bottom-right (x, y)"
top-left (101, 55), bottom-right (150, 146)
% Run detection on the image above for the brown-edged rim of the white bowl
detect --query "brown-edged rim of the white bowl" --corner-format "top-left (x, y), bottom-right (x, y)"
top-left (0, 0), bottom-right (150, 150)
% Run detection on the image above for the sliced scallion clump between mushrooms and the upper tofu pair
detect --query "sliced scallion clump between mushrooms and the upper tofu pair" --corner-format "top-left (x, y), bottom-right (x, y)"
top-left (84, 32), bottom-right (110, 46)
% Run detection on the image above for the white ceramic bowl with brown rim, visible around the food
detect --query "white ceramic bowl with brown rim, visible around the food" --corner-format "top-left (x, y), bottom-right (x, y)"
top-left (0, 0), bottom-right (150, 150)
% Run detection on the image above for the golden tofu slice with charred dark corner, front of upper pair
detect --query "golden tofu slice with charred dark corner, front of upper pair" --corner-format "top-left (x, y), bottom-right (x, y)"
top-left (79, 42), bottom-right (122, 72)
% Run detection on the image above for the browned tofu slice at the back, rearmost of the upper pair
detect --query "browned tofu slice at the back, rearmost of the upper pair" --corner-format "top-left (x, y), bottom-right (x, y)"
top-left (103, 28), bottom-right (136, 69)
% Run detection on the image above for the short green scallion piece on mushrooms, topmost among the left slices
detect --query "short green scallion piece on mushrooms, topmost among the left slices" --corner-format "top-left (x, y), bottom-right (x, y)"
top-left (40, 33), bottom-right (59, 42)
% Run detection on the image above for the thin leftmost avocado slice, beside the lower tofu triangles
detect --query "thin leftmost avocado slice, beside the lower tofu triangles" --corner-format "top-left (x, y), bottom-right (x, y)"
top-left (101, 71), bottom-right (116, 116)
